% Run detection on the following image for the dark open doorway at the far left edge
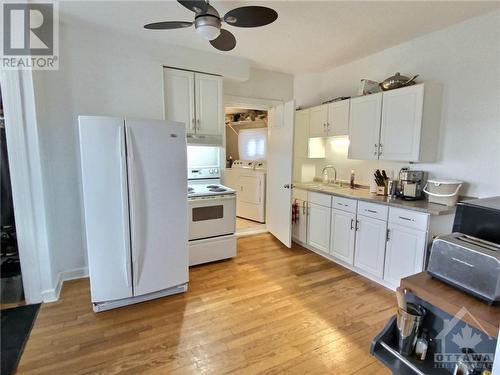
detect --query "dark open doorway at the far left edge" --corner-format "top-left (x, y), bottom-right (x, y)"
top-left (0, 87), bottom-right (24, 309)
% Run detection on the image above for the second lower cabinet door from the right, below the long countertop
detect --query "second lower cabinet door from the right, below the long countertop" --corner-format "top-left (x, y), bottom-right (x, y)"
top-left (354, 216), bottom-right (387, 277)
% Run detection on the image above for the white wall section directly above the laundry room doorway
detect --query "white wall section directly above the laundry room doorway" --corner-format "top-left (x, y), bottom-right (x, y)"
top-left (224, 68), bottom-right (294, 102)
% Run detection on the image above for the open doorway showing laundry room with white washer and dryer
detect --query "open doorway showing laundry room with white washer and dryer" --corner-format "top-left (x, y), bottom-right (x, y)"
top-left (224, 106), bottom-right (268, 236)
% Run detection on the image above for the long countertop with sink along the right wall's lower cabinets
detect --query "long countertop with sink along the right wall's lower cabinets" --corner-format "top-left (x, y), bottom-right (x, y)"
top-left (293, 182), bottom-right (455, 215)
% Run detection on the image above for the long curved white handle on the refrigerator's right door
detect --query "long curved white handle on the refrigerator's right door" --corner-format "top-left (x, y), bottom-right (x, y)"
top-left (125, 126), bottom-right (141, 286)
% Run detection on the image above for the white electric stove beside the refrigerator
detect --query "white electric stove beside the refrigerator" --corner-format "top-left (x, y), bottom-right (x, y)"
top-left (187, 168), bottom-right (236, 266)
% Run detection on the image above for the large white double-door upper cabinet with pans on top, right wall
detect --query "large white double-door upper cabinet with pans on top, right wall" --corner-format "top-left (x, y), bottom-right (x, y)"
top-left (348, 83), bottom-right (442, 162)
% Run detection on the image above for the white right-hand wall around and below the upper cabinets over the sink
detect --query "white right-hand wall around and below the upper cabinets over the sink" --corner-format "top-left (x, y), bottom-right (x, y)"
top-left (294, 11), bottom-right (500, 197)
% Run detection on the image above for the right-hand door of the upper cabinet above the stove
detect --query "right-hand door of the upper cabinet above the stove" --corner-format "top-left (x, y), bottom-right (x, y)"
top-left (194, 73), bottom-right (224, 135)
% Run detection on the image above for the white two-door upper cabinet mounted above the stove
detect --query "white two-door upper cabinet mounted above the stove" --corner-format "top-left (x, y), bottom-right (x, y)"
top-left (164, 68), bottom-right (224, 143)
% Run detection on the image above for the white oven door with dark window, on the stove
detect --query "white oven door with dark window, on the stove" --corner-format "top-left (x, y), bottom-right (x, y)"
top-left (188, 195), bottom-right (236, 240)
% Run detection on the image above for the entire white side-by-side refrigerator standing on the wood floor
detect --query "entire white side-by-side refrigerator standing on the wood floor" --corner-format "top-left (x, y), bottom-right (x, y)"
top-left (78, 116), bottom-right (188, 312)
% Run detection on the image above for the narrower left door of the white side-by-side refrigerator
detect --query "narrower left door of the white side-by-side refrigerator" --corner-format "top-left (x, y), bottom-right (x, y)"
top-left (78, 116), bottom-right (132, 302)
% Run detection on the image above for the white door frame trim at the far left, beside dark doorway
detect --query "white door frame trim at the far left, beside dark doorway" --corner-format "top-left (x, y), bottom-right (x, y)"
top-left (0, 70), bottom-right (53, 304)
